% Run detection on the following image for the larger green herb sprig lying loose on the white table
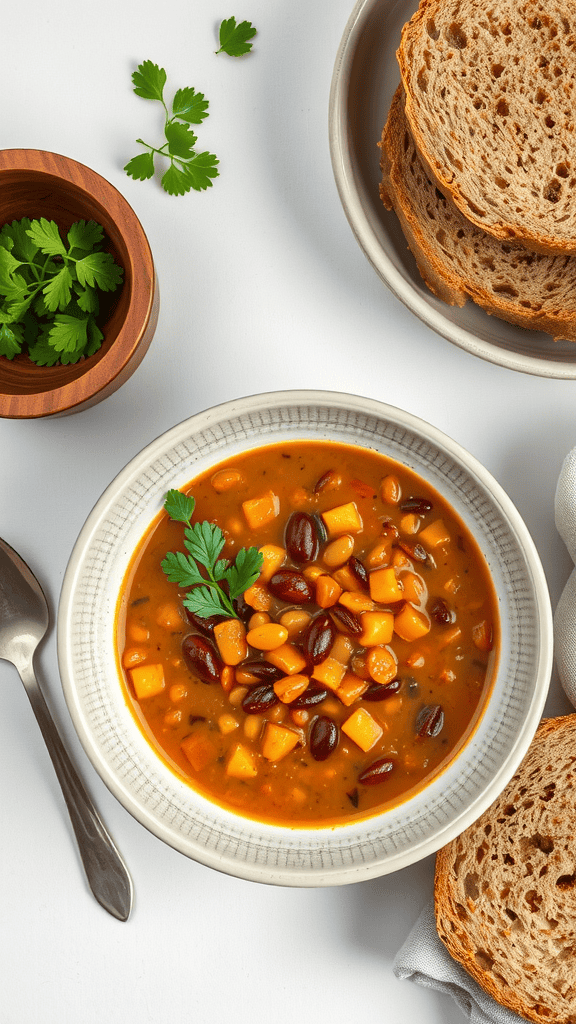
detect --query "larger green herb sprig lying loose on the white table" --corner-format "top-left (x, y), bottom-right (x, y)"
top-left (124, 60), bottom-right (219, 196)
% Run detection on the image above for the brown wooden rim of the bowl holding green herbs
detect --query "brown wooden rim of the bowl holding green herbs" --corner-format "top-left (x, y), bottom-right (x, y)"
top-left (0, 150), bottom-right (158, 419)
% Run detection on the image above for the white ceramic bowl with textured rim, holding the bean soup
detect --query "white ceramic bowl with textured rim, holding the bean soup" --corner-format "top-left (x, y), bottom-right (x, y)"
top-left (58, 391), bottom-right (552, 886)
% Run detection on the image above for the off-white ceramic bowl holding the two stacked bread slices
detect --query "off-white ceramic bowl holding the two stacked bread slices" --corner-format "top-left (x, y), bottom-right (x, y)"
top-left (329, 0), bottom-right (576, 380)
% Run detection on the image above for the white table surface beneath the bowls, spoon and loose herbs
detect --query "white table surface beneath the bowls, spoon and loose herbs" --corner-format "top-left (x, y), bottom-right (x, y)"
top-left (0, 0), bottom-right (576, 1024)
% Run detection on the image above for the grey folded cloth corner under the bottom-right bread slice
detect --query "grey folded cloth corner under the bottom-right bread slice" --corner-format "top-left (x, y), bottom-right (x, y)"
top-left (394, 904), bottom-right (526, 1024)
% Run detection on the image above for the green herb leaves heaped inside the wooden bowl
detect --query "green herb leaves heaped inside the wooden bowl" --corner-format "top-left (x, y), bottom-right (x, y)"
top-left (0, 217), bottom-right (123, 367)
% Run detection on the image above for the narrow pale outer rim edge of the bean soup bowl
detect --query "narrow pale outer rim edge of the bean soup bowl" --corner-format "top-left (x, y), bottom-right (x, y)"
top-left (57, 390), bottom-right (552, 887)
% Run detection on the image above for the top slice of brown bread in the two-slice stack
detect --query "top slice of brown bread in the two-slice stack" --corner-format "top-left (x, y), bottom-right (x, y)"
top-left (398, 0), bottom-right (576, 254)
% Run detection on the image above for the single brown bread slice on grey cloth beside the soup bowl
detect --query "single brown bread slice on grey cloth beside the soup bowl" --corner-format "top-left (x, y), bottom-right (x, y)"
top-left (435, 715), bottom-right (576, 1024)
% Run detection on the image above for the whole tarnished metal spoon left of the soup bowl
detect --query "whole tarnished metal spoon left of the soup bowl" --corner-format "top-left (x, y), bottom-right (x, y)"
top-left (0, 538), bottom-right (132, 921)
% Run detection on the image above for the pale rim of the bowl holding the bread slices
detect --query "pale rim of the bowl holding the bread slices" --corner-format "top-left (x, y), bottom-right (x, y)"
top-left (328, 0), bottom-right (576, 380)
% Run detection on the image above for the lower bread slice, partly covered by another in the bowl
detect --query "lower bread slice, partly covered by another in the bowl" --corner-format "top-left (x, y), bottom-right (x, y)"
top-left (380, 86), bottom-right (576, 341)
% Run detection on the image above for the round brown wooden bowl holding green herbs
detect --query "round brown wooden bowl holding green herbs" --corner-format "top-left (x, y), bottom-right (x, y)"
top-left (0, 150), bottom-right (159, 419)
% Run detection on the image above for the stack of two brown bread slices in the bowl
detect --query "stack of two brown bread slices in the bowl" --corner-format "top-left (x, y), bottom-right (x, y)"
top-left (380, 0), bottom-right (576, 341)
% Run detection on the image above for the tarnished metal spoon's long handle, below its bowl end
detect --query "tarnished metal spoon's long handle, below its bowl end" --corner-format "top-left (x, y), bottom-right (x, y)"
top-left (18, 660), bottom-right (132, 921)
